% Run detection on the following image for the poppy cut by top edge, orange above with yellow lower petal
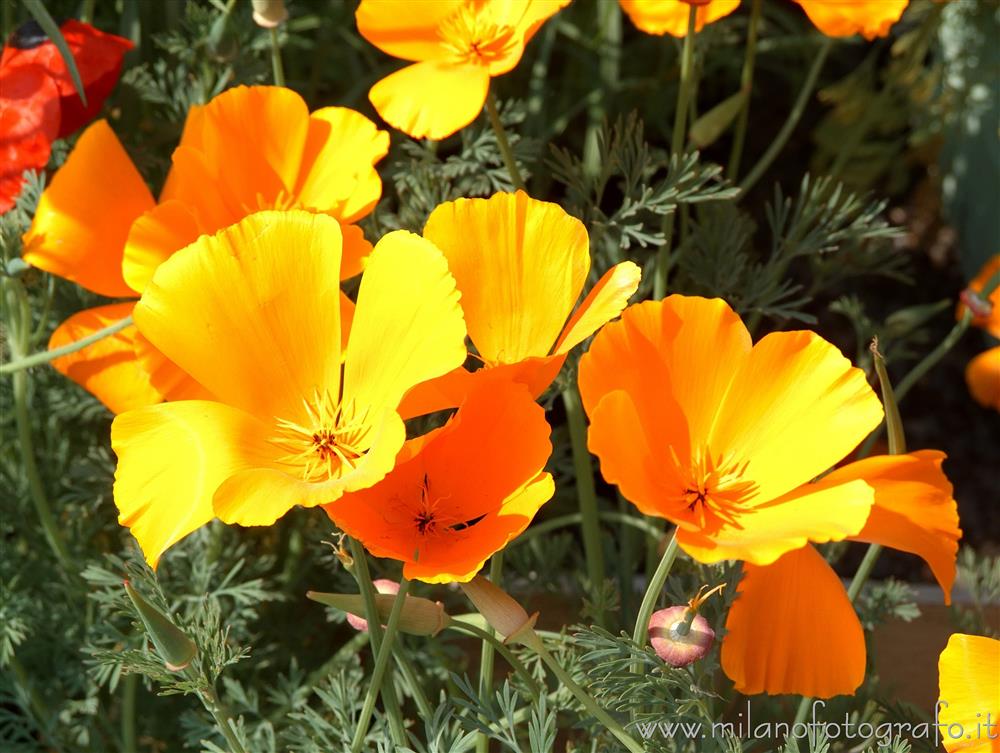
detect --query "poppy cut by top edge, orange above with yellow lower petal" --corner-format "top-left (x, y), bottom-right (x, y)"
top-left (355, 0), bottom-right (569, 139)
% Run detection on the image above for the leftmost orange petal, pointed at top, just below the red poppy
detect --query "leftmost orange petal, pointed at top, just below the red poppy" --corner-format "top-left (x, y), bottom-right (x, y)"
top-left (23, 120), bottom-right (153, 297)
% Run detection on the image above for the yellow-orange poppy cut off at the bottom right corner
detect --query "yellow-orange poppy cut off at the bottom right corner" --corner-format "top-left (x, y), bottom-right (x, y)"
top-left (936, 633), bottom-right (1000, 753)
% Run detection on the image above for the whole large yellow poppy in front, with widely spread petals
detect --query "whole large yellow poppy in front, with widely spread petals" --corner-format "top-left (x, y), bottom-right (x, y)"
top-left (111, 210), bottom-right (465, 565)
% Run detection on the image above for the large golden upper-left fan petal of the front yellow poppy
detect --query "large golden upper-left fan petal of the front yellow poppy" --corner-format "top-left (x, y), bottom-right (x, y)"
top-left (135, 211), bottom-right (344, 422)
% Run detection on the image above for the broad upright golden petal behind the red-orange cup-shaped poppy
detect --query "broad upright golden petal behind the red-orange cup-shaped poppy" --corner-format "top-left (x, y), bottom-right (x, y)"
top-left (424, 191), bottom-right (590, 364)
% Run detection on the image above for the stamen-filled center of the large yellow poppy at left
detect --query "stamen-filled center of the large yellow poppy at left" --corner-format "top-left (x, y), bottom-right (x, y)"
top-left (271, 391), bottom-right (371, 481)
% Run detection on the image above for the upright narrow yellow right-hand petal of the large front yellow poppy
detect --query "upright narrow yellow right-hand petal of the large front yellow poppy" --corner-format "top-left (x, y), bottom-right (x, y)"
top-left (344, 230), bottom-right (466, 412)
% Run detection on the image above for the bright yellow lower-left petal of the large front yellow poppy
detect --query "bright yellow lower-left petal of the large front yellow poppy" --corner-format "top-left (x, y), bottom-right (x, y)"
top-left (111, 400), bottom-right (270, 567)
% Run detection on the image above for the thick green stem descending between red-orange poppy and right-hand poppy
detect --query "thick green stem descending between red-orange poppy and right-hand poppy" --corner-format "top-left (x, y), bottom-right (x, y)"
top-left (562, 386), bottom-right (604, 626)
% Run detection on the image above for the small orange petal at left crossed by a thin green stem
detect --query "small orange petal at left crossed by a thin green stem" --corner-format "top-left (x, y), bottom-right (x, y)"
top-left (49, 302), bottom-right (163, 413)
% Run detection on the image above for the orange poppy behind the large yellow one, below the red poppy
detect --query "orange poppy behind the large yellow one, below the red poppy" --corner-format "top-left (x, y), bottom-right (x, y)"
top-left (24, 86), bottom-right (389, 413)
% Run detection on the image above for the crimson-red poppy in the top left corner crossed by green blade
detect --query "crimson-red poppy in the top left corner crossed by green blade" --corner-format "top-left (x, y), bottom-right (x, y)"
top-left (0, 20), bottom-right (134, 213)
